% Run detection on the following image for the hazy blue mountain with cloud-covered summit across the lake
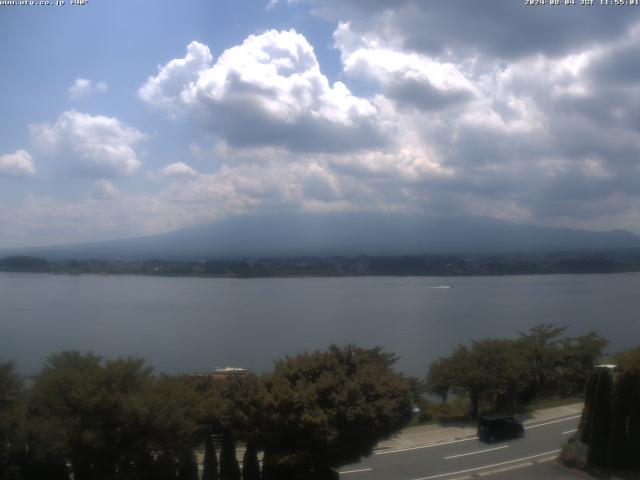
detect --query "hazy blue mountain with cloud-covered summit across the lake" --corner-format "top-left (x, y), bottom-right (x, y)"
top-left (5, 213), bottom-right (640, 260)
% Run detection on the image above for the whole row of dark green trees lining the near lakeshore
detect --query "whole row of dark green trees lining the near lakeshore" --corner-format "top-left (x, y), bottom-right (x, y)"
top-left (0, 324), bottom-right (640, 480)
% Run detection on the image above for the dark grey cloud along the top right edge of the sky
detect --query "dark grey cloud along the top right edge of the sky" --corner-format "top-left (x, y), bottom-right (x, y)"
top-left (316, 0), bottom-right (636, 59)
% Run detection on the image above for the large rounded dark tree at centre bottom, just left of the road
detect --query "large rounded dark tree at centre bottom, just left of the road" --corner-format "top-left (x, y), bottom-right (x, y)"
top-left (261, 345), bottom-right (411, 480)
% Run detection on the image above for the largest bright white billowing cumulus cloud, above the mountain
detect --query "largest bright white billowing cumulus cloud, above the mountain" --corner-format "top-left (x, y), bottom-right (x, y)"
top-left (138, 30), bottom-right (386, 152)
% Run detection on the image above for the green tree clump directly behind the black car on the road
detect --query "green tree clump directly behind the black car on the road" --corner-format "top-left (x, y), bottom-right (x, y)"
top-left (426, 324), bottom-right (607, 417)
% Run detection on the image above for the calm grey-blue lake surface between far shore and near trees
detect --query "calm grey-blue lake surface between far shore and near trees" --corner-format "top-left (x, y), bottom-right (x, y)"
top-left (0, 273), bottom-right (640, 376)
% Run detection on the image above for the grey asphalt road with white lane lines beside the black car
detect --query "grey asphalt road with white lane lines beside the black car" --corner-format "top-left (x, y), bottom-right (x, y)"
top-left (339, 415), bottom-right (580, 480)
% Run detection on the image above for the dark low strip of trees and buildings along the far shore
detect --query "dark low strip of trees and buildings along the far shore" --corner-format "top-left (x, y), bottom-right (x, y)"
top-left (0, 250), bottom-right (640, 277)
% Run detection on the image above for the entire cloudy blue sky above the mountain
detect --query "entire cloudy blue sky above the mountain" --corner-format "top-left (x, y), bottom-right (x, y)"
top-left (0, 0), bottom-right (640, 247)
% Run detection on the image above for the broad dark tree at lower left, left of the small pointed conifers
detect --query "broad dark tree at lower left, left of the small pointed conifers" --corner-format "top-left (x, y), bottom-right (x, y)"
top-left (29, 352), bottom-right (201, 480)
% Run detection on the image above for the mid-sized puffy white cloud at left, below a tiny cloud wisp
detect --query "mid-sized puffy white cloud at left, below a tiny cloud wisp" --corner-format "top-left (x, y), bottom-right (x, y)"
top-left (29, 110), bottom-right (145, 178)
